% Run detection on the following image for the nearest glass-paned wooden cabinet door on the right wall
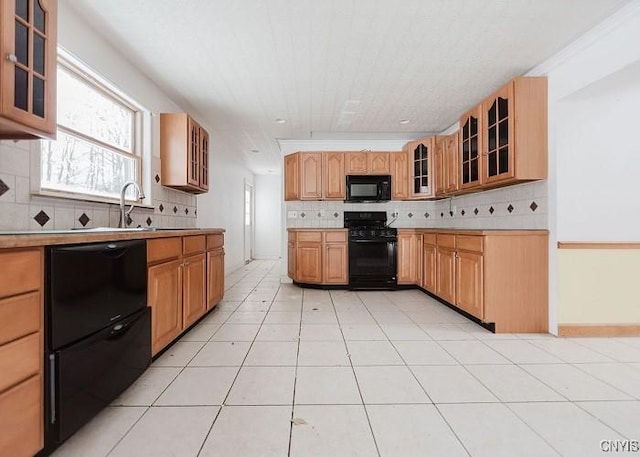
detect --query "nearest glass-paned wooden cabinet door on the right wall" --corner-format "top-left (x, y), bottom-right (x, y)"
top-left (482, 84), bottom-right (514, 183)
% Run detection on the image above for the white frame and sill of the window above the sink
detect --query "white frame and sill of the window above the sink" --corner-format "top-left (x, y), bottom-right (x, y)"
top-left (31, 47), bottom-right (152, 208)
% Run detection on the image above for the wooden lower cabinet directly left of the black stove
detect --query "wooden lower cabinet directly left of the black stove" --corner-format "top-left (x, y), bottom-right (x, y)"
top-left (287, 230), bottom-right (349, 285)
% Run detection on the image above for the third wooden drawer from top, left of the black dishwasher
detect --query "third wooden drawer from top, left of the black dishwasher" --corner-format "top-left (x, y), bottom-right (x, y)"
top-left (0, 333), bottom-right (43, 392)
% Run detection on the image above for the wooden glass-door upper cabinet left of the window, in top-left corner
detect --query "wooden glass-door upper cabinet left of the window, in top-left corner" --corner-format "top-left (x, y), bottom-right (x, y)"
top-left (0, 0), bottom-right (58, 139)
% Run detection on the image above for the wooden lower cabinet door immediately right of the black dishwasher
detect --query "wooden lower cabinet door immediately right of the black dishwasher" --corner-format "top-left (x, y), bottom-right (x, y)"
top-left (147, 260), bottom-right (182, 355)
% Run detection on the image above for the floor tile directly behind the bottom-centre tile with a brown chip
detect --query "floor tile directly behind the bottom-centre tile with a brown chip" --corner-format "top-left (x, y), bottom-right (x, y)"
top-left (295, 367), bottom-right (362, 405)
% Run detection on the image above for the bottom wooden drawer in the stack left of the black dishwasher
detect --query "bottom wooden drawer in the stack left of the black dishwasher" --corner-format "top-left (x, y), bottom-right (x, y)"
top-left (0, 376), bottom-right (43, 456)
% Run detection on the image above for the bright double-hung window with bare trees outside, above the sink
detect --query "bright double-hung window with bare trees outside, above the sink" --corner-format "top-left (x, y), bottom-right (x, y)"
top-left (40, 54), bottom-right (141, 200)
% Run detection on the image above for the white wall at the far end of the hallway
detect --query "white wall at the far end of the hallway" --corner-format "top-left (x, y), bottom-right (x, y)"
top-left (254, 175), bottom-right (282, 259)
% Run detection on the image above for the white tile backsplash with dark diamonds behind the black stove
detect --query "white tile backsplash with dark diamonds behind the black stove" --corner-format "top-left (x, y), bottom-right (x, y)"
top-left (286, 181), bottom-right (547, 229)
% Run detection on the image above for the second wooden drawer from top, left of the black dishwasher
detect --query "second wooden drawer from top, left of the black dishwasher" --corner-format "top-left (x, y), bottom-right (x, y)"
top-left (0, 292), bottom-right (41, 344)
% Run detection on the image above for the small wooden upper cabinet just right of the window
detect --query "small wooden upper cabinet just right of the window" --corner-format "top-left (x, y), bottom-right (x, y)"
top-left (160, 113), bottom-right (209, 194)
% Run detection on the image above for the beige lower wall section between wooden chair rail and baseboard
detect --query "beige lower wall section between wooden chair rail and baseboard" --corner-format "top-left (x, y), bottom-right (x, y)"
top-left (557, 248), bottom-right (640, 325)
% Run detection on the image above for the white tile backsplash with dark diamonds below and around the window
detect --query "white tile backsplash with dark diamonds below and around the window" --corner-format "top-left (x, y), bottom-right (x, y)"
top-left (0, 140), bottom-right (197, 230)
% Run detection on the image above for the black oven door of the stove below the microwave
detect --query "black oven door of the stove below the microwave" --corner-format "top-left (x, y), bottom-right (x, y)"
top-left (349, 239), bottom-right (397, 289)
